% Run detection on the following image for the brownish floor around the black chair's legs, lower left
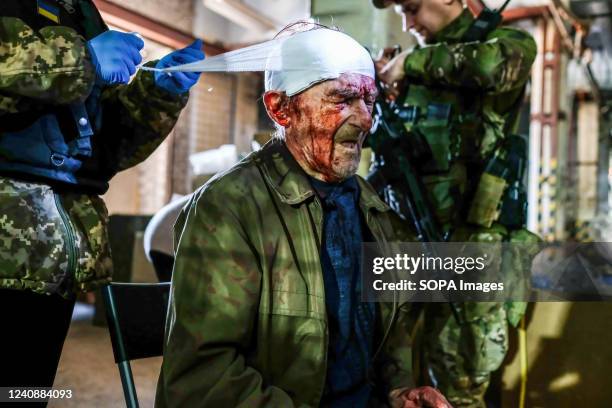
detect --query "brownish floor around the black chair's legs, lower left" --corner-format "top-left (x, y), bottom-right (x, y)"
top-left (49, 303), bottom-right (162, 408)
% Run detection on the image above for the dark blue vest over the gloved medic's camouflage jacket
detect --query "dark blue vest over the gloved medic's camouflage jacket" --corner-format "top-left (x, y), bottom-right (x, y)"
top-left (0, 0), bottom-right (108, 192)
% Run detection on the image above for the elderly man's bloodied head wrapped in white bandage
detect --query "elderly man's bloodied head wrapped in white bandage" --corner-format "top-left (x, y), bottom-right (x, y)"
top-left (264, 28), bottom-right (377, 183)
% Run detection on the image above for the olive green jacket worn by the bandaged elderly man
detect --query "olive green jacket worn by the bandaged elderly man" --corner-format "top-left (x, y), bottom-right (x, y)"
top-left (156, 141), bottom-right (412, 407)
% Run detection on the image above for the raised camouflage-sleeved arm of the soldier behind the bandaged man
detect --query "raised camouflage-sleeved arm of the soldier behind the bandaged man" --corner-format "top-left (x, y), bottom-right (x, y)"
top-left (404, 28), bottom-right (536, 93)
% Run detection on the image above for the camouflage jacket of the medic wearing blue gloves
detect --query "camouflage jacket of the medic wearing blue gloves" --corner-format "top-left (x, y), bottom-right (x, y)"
top-left (0, 6), bottom-right (188, 297)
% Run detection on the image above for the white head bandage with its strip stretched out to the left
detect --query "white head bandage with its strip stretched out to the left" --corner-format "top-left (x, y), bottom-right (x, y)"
top-left (142, 28), bottom-right (374, 96)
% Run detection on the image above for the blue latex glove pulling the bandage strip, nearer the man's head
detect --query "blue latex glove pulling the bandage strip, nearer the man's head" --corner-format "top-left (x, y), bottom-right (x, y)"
top-left (155, 40), bottom-right (205, 95)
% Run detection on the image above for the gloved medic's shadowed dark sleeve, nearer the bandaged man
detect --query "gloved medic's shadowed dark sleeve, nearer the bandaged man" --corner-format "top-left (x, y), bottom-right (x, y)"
top-left (94, 61), bottom-right (189, 171)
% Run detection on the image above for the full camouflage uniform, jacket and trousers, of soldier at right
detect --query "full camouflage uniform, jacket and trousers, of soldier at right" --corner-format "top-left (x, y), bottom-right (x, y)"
top-left (390, 9), bottom-right (538, 407)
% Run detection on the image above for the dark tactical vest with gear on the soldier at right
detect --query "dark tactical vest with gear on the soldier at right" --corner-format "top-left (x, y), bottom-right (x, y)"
top-left (400, 68), bottom-right (522, 231)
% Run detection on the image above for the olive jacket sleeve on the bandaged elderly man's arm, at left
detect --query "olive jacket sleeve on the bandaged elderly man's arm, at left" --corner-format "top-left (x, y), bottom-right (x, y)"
top-left (156, 184), bottom-right (293, 408)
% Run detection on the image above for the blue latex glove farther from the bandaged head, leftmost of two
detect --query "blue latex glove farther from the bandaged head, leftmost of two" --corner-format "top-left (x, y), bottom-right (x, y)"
top-left (87, 30), bottom-right (144, 85)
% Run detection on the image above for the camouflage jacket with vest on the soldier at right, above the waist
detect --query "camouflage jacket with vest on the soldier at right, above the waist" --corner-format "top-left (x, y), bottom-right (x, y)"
top-left (401, 9), bottom-right (536, 225)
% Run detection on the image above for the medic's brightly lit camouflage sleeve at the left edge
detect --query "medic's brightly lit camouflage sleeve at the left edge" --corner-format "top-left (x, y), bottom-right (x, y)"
top-left (0, 17), bottom-right (95, 112)
